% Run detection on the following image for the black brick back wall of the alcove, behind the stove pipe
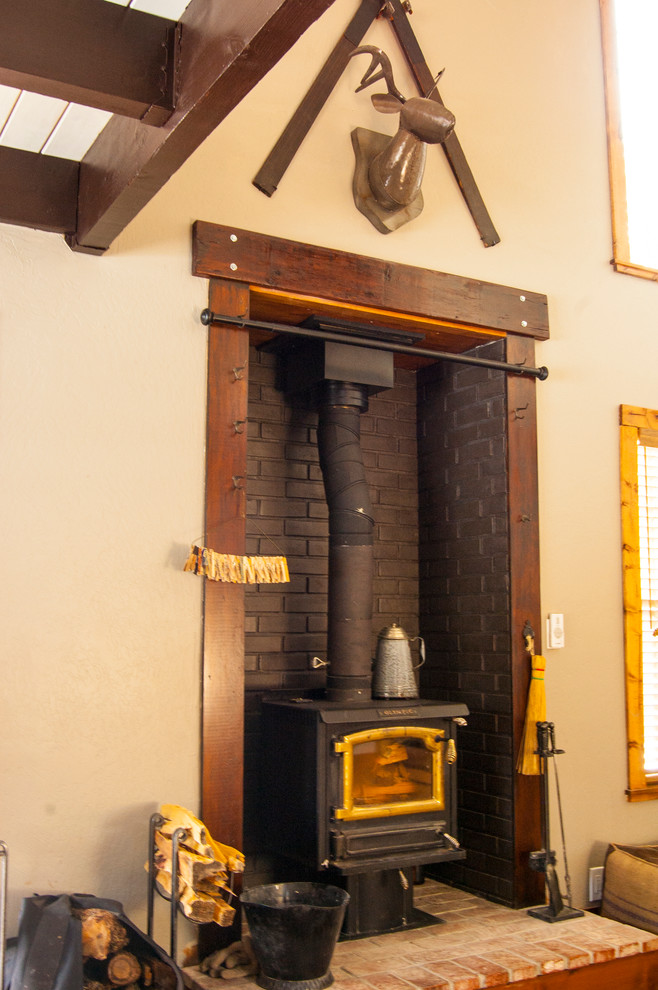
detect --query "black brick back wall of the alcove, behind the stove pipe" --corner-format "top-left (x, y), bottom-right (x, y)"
top-left (244, 349), bottom-right (418, 868)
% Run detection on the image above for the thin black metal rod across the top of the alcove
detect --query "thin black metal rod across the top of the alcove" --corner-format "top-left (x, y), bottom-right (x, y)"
top-left (200, 309), bottom-right (548, 382)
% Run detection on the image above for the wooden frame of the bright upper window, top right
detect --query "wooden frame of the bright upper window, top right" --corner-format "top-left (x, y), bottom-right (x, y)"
top-left (599, 0), bottom-right (658, 281)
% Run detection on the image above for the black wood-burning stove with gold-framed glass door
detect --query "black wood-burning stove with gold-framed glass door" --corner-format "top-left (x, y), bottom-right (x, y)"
top-left (263, 699), bottom-right (468, 936)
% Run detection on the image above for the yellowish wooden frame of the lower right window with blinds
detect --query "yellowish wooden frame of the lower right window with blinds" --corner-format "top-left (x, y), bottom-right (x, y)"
top-left (619, 405), bottom-right (658, 801)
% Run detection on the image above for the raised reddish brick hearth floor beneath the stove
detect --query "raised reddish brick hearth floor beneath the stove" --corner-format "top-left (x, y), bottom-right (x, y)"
top-left (184, 880), bottom-right (658, 990)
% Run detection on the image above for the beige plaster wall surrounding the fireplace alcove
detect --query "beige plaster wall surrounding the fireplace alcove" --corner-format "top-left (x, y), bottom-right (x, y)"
top-left (0, 0), bottom-right (658, 928)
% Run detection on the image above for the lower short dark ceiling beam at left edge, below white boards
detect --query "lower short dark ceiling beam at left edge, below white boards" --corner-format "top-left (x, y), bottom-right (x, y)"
top-left (0, 147), bottom-right (79, 234)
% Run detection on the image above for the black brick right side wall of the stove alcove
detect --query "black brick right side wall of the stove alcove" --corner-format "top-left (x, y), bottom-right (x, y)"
top-left (418, 342), bottom-right (514, 903)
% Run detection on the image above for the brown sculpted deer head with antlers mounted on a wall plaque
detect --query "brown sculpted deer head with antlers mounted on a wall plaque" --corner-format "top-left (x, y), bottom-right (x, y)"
top-left (350, 45), bottom-right (455, 234)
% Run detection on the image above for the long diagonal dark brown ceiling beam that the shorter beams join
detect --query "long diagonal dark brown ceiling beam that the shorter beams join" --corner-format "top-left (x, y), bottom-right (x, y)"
top-left (68, 0), bottom-right (334, 254)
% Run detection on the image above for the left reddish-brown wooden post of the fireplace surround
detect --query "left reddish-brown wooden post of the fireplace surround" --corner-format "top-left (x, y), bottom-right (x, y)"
top-left (200, 279), bottom-right (249, 951)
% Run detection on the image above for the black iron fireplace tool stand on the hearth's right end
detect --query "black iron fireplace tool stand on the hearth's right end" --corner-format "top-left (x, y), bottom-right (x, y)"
top-left (528, 722), bottom-right (585, 923)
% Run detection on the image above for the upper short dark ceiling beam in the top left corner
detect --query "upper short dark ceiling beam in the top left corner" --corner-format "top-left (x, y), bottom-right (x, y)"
top-left (0, 0), bottom-right (176, 125)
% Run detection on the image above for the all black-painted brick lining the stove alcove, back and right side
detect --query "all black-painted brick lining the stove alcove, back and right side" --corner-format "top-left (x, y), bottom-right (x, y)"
top-left (244, 342), bottom-right (514, 903)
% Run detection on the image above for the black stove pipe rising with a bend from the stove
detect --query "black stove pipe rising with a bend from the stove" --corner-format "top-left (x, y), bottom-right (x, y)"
top-left (318, 381), bottom-right (375, 702)
